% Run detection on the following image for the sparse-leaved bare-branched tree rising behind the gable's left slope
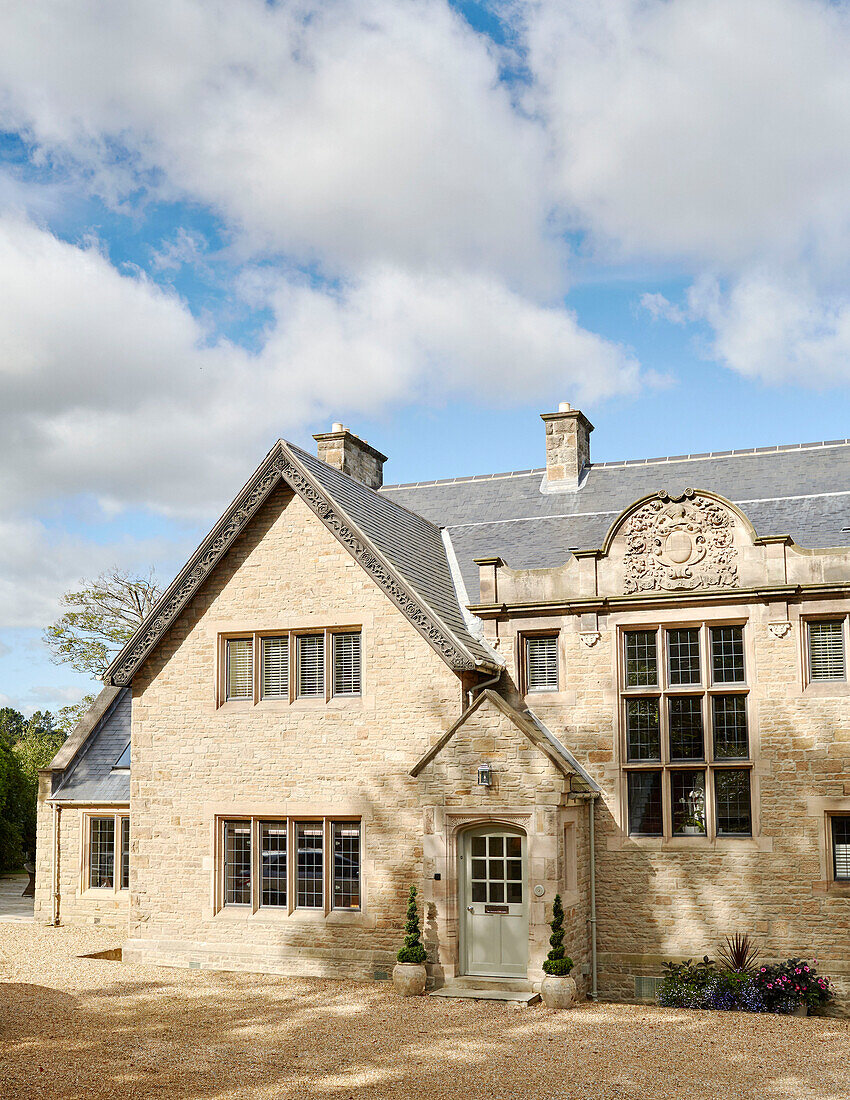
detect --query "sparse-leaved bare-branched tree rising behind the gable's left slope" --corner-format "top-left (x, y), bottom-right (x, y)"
top-left (44, 569), bottom-right (162, 680)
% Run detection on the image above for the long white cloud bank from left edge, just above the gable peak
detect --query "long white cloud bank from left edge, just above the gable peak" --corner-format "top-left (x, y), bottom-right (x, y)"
top-left (0, 217), bottom-right (638, 516)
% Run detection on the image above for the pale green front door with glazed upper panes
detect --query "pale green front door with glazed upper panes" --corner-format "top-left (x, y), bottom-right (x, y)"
top-left (461, 826), bottom-right (528, 978)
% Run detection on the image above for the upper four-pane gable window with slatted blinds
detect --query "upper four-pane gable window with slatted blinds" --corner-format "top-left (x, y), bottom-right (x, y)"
top-left (219, 627), bottom-right (363, 704)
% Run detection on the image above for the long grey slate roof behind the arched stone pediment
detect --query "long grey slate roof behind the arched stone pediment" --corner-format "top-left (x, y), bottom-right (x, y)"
top-left (380, 440), bottom-right (850, 603)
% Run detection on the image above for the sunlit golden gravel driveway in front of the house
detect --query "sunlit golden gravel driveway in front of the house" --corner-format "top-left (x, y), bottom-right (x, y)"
top-left (0, 924), bottom-right (850, 1100)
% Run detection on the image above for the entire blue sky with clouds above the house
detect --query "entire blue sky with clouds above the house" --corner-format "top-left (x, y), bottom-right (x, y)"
top-left (0, 0), bottom-right (850, 713)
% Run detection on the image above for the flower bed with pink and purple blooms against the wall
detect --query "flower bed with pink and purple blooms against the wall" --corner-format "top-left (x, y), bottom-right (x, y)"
top-left (658, 956), bottom-right (832, 1015)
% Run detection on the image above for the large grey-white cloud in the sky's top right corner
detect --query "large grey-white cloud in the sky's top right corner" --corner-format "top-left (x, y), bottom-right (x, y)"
top-left (527, 0), bottom-right (850, 268)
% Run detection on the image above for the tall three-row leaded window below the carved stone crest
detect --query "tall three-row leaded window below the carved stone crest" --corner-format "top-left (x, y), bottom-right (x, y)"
top-left (620, 623), bottom-right (752, 837)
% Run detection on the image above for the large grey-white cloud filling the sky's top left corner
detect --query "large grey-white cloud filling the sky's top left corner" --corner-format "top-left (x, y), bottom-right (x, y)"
top-left (0, 0), bottom-right (555, 286)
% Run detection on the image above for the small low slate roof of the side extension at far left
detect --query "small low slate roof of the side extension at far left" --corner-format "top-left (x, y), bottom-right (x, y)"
top-left (51, 688), bottom-right (132, 803)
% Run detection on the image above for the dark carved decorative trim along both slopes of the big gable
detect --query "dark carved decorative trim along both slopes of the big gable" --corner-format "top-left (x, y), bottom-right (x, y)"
top-left (110, 442), bottom-right (475, 686)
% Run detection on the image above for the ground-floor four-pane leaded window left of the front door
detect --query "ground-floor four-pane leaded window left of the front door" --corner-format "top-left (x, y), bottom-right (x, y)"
top-left (218, 817), bottom-right (362, 913)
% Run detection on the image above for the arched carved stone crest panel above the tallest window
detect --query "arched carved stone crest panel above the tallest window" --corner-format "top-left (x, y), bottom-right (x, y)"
top-left (623, 488), bottom-right (738, 593)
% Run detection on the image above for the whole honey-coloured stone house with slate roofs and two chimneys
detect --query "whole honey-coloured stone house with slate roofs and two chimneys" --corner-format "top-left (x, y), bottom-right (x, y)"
top-left (36, 405), bottom-right (850, 1008)
